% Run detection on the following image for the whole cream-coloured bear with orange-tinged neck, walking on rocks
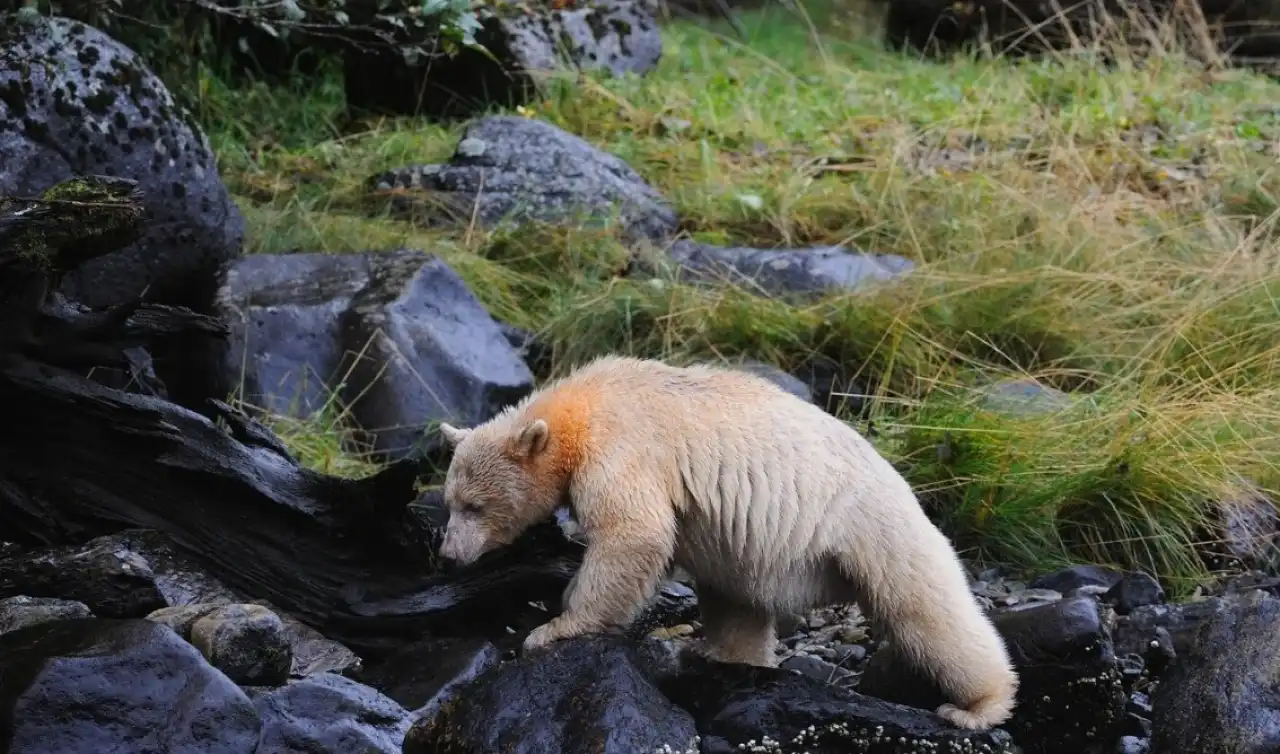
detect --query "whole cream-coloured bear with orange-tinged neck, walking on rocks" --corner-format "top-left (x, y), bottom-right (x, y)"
top-left (442, 356), bottom-right (1018, 728)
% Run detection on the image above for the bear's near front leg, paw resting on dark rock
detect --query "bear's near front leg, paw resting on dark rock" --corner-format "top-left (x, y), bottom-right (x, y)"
top-left (524, 509), bottom-right (675, 650)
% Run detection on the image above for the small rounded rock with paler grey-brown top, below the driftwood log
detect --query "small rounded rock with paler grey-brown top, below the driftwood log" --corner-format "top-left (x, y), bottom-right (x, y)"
top-left (191, 604), bottom-right (293, 686)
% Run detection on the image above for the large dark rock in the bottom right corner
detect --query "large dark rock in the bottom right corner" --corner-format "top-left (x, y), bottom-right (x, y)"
top-left (1151, 591), bottom-right (1280, 754)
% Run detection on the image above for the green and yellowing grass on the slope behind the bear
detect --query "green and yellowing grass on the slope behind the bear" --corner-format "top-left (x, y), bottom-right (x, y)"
top-left (186, 2), bottom-right (1280, 593)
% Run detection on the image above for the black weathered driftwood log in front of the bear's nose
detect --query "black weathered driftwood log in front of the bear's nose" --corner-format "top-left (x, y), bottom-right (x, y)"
top-left (0, 177), bottom-right (580, 653)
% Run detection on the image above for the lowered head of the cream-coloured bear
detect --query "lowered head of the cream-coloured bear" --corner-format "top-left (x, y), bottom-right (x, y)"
top-left (440, 417), bottom-right (563, 566)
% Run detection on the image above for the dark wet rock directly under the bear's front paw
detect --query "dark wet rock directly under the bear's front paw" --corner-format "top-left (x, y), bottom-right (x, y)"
top-left (404, 636), bottom-right (696, 754)
